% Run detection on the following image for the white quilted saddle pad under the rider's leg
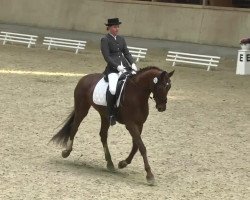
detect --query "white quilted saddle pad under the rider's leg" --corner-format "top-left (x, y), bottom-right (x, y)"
top-left (93, 78), bottom-right (126, 107)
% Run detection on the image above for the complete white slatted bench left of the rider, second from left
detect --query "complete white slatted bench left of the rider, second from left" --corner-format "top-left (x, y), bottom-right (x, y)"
top-left (43, 37), bottom-right (87, 54)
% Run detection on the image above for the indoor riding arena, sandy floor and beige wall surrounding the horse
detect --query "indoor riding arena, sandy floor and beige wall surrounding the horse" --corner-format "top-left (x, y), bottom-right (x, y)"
top-left (0, 0), bottom-right (250, 200)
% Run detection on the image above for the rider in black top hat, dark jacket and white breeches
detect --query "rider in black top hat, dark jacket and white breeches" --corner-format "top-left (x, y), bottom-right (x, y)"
top-left (101, 18), bottom-right (137, 125)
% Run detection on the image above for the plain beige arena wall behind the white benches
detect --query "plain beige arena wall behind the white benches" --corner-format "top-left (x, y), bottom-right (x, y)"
top-left (0, 0), bottom-right (250, 47)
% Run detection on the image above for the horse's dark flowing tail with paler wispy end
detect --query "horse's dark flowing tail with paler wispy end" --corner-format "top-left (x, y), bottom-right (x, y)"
top-left (50, 110), bottom-right (75, 146)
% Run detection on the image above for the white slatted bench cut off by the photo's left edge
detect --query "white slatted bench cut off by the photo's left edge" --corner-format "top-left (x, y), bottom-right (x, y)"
top-left (0, 31), bottom-right (38, 48)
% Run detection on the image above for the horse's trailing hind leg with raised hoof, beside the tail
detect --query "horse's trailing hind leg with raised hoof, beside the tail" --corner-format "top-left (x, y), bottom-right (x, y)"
top-left (62, 101), bottom-right (90, 158)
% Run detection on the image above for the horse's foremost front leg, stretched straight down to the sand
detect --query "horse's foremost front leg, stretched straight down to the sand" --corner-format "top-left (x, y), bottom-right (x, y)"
top-left (127, 125), bottom-right (155, 185)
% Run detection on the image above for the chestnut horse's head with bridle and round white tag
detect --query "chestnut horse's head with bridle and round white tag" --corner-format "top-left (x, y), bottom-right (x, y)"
top-left (152, 71), bottom-right (174, 112)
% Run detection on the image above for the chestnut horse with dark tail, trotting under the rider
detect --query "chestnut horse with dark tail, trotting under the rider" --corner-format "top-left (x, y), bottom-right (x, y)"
top-left (51, 66), bottom-right (174, 185)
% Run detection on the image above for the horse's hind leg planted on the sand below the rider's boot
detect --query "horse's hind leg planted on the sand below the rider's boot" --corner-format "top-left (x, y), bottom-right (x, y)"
top-left (99, 117), bottom-right (115, 171)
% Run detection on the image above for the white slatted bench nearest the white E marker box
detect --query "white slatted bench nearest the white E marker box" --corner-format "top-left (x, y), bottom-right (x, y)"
top-left (166, 51), bottom-right (220, 71)
